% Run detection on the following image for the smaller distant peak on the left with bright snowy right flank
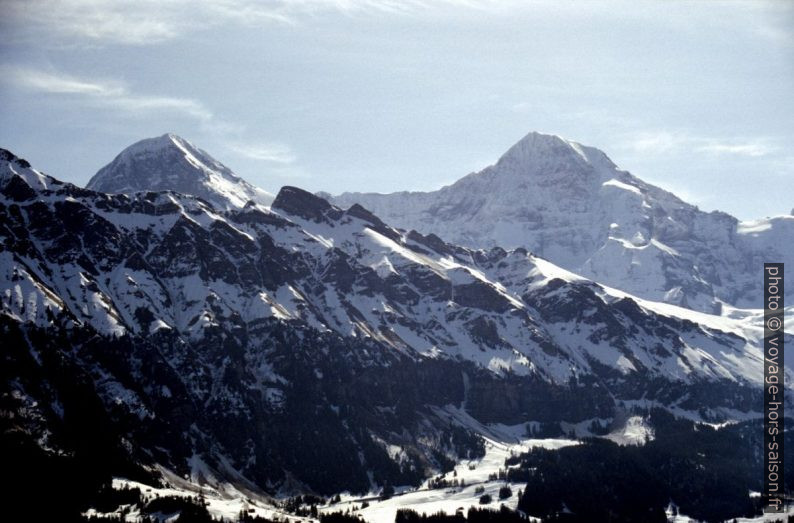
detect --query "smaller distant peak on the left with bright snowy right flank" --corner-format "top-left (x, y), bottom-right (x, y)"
top-left (87, 134), bottom-right (273, 209)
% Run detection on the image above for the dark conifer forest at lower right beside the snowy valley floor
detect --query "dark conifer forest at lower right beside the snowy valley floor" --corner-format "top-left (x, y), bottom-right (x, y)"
top-left (507, 409), bottom-right (794, 523)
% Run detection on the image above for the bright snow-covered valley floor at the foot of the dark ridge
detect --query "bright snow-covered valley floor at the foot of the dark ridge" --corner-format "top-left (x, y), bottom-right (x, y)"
top-left (87, 420), bottom-right (794, 523)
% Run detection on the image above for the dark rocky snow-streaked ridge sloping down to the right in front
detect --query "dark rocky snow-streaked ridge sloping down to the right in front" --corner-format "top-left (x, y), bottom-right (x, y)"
top-left (0, 144), bottom-right (794, 500)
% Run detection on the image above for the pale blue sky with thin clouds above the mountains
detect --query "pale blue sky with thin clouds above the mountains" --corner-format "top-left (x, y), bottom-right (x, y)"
top-left (0, 0), bottom-right (794, 220)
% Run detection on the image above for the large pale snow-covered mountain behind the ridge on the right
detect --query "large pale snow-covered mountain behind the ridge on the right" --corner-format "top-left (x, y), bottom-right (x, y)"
top-left (331, 133), bottom-right (794, 313)
